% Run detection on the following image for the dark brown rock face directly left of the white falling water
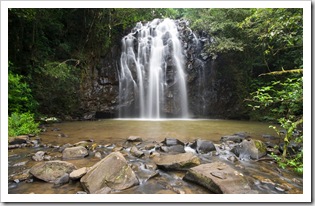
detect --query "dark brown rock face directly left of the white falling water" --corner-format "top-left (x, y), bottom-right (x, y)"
top-left (80, 45), bottom-right (120, 120)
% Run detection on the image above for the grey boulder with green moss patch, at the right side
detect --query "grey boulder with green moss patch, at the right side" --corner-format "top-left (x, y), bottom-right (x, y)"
top-left (231, 139), bottom-right (267, 160)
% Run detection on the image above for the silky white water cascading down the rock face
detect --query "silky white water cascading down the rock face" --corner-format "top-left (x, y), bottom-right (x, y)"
top-left (119, 19), bottom-right (188, 119)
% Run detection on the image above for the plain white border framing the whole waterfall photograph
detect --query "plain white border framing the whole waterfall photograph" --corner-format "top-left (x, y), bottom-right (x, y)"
top-left (0, 1), bottom-right (312, 203)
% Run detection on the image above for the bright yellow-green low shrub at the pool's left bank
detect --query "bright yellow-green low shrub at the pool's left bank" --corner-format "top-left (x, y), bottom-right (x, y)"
top-left (8, 112), bottom-right (40, 137)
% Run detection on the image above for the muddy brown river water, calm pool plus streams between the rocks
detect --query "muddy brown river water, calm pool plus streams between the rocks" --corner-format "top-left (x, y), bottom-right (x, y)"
top-left (9, 119), bottom-right (303, 194)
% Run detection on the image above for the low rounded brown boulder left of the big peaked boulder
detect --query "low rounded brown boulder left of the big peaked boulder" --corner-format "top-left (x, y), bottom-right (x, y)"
top-left (30, 160), bottom-right (76, 183)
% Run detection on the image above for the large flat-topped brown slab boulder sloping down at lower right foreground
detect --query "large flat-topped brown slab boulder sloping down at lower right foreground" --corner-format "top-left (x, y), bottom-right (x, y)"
top-left (184, 162), bottom-right (257, 194)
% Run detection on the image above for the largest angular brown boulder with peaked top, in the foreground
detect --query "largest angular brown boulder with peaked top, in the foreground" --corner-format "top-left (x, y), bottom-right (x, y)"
top-left (80, 152), bottom-right (139, 193)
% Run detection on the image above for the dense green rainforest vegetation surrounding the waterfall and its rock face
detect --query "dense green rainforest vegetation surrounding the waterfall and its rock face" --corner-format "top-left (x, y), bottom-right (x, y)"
top-left (8, 8), bottom-right (303, 172)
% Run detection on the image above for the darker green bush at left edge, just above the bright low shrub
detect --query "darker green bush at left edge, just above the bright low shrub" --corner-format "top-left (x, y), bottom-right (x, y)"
top-left (8, 67), bottom-right (38, 114)
